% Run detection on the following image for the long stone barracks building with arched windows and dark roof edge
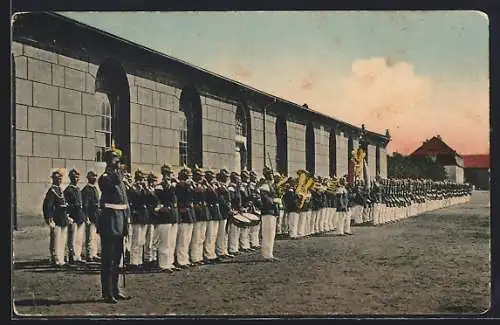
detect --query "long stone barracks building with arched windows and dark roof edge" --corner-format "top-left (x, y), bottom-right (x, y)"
top-left (11, 13), bottom-right (390, 224)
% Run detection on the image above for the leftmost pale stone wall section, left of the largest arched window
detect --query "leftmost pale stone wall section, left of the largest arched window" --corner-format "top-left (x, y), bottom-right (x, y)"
top-left (12, 42), bottom-right (103, 216)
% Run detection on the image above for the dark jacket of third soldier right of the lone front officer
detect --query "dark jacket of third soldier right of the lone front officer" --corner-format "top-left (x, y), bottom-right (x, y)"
top-left (155, 181), bottom-right (179, 224)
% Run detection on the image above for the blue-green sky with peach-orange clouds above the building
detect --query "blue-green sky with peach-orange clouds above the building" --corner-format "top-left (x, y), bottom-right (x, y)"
top-left (62, 11), bottom-right (490, 154)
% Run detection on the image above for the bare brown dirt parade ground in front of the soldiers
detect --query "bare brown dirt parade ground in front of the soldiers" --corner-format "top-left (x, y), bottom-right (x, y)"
top-left (12, 192), bottom-right (490, 316)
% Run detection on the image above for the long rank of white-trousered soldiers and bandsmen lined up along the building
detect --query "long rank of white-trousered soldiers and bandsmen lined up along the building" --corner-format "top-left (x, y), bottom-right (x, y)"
top-left (43, 144), bottom-right (472, 300)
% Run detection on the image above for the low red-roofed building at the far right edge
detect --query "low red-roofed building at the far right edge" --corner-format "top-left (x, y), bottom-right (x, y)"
top-left (464, 154), bottom-right (490, 190)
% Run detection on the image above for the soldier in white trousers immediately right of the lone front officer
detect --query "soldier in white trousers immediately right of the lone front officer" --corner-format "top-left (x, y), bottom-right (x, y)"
top-left (129, 169), bottom-right (151, 270)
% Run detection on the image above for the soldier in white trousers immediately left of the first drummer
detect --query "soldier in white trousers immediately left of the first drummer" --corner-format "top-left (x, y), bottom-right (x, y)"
top-left (215, 168), bottom-right (234, 258)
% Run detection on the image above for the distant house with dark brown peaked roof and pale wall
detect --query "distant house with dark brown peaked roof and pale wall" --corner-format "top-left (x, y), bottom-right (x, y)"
top-left (410, 135), bottom-right (464, 183)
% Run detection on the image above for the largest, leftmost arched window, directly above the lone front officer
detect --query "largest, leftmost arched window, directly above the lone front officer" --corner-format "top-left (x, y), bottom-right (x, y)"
top-left (95, 58), bottom-right (131, 168)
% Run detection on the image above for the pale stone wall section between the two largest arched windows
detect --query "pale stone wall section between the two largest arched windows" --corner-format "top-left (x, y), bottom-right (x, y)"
top-left (127, 74), bottom-right (181, 174)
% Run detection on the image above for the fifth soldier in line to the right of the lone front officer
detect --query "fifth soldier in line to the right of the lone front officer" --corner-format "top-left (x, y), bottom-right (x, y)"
top-left (190, 166), bottom-right (209, 265)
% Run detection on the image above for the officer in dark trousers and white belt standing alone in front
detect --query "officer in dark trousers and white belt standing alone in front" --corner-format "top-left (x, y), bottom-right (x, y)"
top-left (97, 145), bottom-right (131, 304)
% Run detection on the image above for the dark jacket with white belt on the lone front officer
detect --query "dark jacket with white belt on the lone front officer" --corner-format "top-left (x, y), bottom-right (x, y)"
top-left (97, 170), bottom-right (130, 237)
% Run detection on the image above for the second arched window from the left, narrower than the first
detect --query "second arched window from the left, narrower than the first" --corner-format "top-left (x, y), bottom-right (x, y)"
top-left (179, 87), bottom-right (203, 168)
